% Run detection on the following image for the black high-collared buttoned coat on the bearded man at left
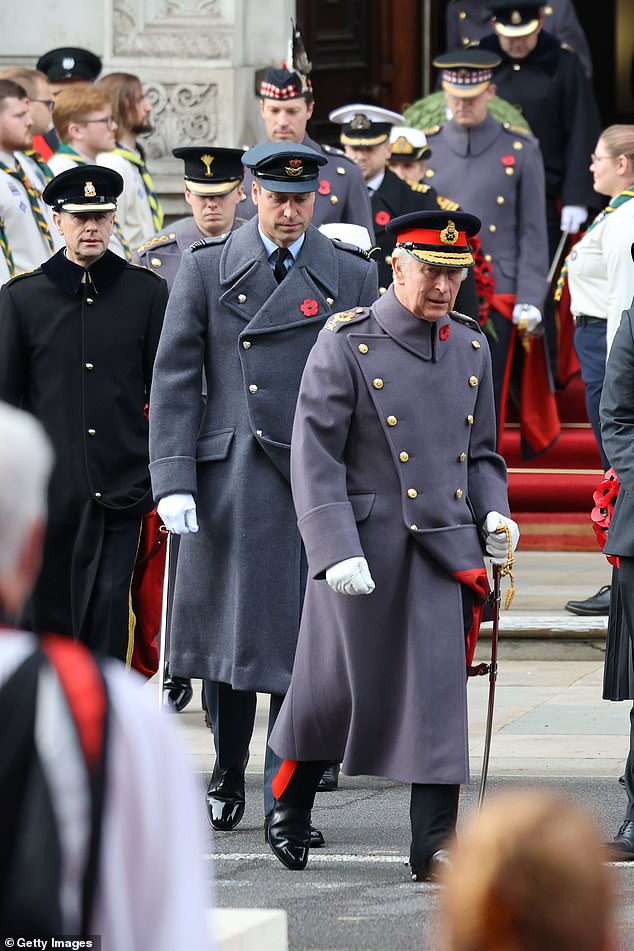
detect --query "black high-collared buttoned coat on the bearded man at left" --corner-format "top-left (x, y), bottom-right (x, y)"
top-left (0, 251), bottom-right (167, 525)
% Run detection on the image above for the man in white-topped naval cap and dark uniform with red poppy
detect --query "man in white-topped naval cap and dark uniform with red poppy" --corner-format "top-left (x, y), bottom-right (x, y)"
top-left (328, 103), bottom-right (479, 319)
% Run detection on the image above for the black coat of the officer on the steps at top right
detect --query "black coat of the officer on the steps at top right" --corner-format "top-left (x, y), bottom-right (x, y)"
top-left (479, 30), bottom-right (602, 206)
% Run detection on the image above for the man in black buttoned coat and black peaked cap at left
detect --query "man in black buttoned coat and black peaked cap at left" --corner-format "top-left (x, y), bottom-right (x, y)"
top-left (0, 165), bottom-right (167, 661)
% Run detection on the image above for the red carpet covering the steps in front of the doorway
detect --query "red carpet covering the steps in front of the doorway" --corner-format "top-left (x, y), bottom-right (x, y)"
top-left (501, 374), bottom-right (603, 551)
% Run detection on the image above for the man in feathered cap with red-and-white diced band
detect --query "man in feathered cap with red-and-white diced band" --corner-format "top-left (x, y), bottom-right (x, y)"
top-left (240, 67), bottom-right (374, 238)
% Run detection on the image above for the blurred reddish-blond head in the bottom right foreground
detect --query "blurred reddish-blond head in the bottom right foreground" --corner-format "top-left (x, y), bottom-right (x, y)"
top-left (441, 790), bottom-right (616, 951)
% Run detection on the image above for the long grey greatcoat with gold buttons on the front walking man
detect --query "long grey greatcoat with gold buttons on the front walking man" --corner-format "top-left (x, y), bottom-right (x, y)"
top-left (270, 288), bottom-right (508, 783)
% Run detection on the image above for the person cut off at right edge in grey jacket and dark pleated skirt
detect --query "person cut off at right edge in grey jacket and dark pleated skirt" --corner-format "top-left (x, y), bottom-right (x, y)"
top-left (601, 302), bottom-right (634, 861)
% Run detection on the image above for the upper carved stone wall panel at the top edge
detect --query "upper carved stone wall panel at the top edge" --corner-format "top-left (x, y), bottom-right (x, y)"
top-left (112, 0), bottom-right (233, 61)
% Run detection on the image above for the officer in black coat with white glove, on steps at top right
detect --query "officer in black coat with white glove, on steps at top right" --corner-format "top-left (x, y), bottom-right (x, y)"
top-left (479, 0), bottom-right (602, 259)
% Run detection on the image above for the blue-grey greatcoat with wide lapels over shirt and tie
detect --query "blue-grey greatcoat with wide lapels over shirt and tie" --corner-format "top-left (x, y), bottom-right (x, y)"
top-left (150, 219), bottom-right (378, 693)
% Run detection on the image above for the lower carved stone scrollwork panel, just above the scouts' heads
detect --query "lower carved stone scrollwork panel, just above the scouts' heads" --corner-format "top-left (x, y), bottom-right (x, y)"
top-left (144, 82), bottom-right (218, 161)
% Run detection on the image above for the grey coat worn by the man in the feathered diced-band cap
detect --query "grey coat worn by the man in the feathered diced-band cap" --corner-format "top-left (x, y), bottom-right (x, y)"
top-left (238, 135), bottom-right (374, 240)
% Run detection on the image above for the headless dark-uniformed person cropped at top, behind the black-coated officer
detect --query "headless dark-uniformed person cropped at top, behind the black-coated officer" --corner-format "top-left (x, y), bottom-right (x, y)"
top-left (446, 0), bottom-right (592, 77)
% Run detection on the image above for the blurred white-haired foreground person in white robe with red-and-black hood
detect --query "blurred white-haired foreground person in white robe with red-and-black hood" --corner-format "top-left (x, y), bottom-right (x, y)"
top-left (0, 403), bottom-right (211, 951)
